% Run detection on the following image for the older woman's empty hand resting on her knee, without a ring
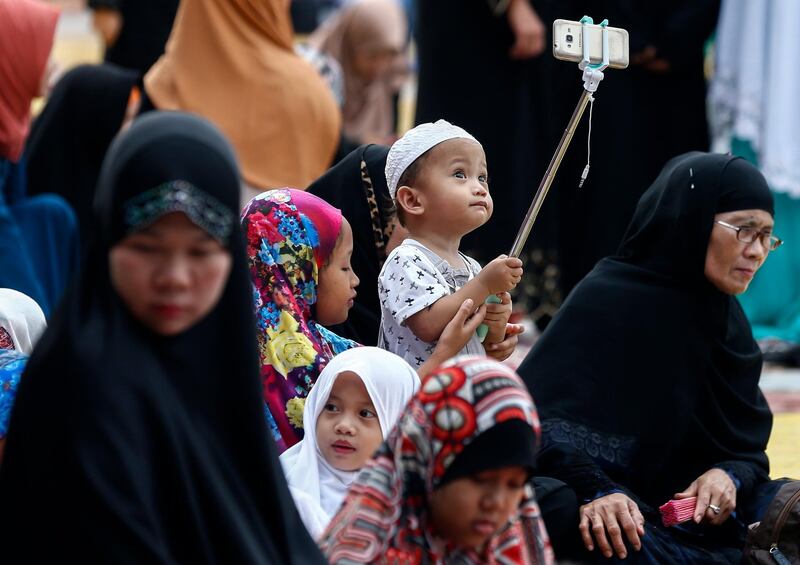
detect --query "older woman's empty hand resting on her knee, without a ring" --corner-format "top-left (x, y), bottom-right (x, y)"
top-left (579, 492), bottom-right (644, 559)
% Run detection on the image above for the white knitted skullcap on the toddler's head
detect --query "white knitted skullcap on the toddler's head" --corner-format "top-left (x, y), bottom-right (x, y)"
top-left (386, 120), bottom-right (480, 199)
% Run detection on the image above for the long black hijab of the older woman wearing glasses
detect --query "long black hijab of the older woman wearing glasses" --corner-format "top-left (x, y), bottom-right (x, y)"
top-left (519, 152), bottom-right (772, 504)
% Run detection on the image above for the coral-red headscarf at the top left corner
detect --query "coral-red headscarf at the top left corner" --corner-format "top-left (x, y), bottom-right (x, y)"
top-left (0, 0), bottom-right (59, 163)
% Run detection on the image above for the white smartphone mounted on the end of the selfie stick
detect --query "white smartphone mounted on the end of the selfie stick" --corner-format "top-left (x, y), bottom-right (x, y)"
top-left (553, 20), bottom-right (630, 69)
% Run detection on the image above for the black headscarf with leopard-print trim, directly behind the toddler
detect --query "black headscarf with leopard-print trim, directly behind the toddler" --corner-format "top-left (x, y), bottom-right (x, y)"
top-left (308, 145), bottom-right (394, 345)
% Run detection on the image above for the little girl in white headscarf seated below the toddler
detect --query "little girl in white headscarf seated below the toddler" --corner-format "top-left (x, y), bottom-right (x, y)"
top-left (281, 347), bottom-right (419, 539)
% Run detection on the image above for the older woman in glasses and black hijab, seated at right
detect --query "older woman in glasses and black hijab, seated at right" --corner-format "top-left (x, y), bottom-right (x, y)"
top-left (519, 152), bottom-right (780, 563)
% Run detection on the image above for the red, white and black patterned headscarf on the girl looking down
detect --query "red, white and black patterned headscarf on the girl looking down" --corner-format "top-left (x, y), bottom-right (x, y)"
top-left (319, 357), bottom-right (553, 565)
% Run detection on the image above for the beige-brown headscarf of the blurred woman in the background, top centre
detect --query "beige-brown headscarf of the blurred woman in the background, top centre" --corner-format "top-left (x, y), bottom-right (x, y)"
top-left (308, 0), bottom-right (410, 143)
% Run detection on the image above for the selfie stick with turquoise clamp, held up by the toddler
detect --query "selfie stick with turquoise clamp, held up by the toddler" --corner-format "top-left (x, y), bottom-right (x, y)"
top-left (477, 16), bottom-right (620, 341)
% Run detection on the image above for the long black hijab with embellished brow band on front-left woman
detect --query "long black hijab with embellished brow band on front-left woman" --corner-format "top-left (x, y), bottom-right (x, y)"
top-left (0, 113), bottom-right (322, 564)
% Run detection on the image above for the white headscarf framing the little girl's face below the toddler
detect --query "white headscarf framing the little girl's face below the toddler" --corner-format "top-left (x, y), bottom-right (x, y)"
top-left (281, 347), bottom-right (419, 539)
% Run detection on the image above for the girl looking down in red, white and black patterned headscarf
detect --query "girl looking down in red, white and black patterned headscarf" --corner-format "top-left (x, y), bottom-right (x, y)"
top-left (318, 357), bottom-right (553, 565)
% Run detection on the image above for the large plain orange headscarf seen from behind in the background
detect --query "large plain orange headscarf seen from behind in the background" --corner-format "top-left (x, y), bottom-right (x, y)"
top-left (145, 0), bottom-right (341, 189)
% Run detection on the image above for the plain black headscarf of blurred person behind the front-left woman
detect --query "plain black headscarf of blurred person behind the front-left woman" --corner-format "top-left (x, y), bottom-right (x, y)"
top-left (25, 65), bottom-right (138, 234)
